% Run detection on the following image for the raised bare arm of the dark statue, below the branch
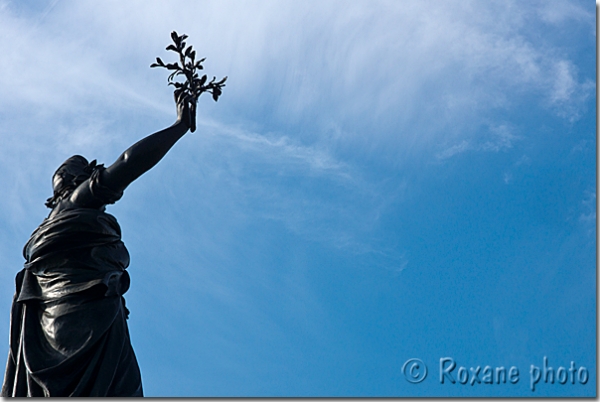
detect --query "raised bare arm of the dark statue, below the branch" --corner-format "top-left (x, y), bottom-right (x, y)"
top-left (70, 97), bottom-right (193, 207)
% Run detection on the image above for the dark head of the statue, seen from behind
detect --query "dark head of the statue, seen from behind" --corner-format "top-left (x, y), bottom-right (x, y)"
top-left (46, 155), bottom-right (96, 208)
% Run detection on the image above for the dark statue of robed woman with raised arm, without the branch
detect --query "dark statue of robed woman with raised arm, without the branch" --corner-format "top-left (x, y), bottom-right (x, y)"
top-left (1, 97), bottom-right (195, 397)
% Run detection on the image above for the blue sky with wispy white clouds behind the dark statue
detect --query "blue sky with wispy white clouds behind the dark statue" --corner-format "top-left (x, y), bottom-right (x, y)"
top-left (0, 0), bottom-right (597, 396)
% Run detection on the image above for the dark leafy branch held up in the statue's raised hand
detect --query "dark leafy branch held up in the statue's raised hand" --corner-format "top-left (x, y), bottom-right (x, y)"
top-left (150, 31), bottom-right (227, 132)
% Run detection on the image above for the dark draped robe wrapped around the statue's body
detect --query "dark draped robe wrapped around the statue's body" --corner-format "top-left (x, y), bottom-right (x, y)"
top-left (1, 208), bottom-right (143, 397)
